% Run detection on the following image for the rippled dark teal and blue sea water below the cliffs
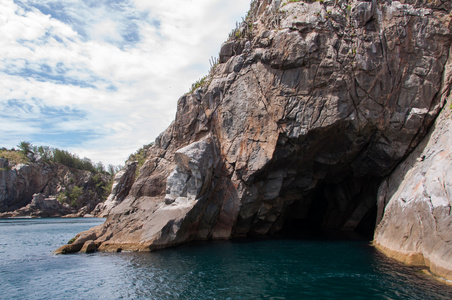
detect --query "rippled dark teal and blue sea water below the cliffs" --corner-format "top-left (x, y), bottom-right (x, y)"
top-left (0, 218), bottom-right (452, 300)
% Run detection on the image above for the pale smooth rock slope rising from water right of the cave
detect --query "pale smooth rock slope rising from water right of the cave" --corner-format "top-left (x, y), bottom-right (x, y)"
top-left (374, 100), bottom-right (452, 279)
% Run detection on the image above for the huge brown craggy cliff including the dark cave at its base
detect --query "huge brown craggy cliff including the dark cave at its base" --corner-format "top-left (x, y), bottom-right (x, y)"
top-left (59, 0), bottom-right (452, 282)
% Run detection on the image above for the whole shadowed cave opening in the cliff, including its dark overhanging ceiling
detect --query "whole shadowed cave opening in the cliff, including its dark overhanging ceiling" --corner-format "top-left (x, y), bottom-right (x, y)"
top-left (247, 121), bottom-right (384, 240)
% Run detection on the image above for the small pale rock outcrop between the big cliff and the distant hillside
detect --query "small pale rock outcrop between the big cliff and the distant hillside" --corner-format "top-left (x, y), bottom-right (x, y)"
top-left (94, 161), bottom-right (138, 218)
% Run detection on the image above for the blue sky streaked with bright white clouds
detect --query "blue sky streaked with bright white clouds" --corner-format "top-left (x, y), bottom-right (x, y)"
top-left (0, 0), bottom-right (250, 165)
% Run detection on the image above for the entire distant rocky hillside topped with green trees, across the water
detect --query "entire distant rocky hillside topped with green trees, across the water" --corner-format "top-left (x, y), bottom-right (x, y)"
top-left (0, 142), bottom-right (116, 217)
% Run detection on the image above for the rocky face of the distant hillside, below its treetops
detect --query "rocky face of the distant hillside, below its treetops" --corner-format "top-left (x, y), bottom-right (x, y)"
top-left (0, 158), bottom-right (110, 217)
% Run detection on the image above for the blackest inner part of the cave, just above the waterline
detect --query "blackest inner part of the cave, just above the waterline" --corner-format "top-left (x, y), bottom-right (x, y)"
top-left (277, 176), bottom-right (381, 240)
